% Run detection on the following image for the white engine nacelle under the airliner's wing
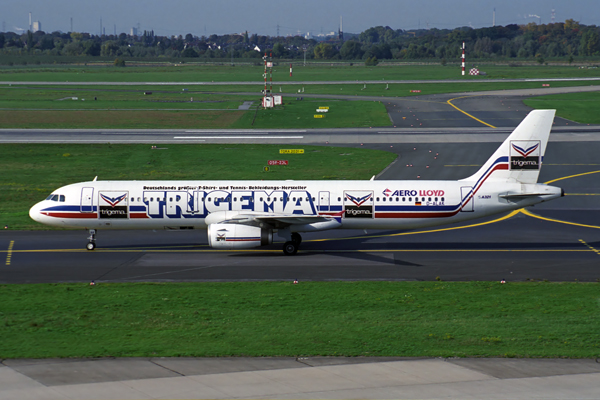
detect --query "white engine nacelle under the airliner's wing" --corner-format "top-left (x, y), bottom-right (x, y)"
top-left (208, 223), bottom-right (273, 249)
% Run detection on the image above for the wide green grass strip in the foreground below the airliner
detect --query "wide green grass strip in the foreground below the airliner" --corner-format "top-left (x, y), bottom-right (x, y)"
top-left (0, 282), bottom-right (600, 358)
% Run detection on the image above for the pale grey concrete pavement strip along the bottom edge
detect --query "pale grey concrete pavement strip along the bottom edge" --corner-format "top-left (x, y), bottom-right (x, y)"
top-left (0, 357), bottom-right (600, 400)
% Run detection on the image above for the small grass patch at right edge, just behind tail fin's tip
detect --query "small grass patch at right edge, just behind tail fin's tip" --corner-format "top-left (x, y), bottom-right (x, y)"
top-left (523, 92), bottom-right (600, 124)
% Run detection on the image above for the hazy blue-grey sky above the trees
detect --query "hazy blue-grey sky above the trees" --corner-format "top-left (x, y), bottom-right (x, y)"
top-left (0, 0), bottom-right (600, 36)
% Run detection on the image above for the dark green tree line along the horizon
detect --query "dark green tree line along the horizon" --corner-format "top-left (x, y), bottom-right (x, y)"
top-left (0, 19), bottom-right (600, 64)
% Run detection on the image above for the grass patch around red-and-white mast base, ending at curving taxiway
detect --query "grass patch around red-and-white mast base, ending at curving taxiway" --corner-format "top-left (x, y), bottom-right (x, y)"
top-left (0, 86), bottom-right (390, 129)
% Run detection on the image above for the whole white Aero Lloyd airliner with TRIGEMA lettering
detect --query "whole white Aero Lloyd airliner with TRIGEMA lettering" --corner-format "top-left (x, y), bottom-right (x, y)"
top-left (29, 110), bottom-right (564, 255)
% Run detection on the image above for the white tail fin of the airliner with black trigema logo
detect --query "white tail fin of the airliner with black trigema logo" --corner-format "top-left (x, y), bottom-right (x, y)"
top-left (463, 110), bottom-right (556, 183)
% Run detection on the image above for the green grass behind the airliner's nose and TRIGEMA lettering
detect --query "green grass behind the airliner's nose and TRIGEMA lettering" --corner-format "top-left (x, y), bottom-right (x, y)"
top-left (0, 144), bottom-right (396, 229)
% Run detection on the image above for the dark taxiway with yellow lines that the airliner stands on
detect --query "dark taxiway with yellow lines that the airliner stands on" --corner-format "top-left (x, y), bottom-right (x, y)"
top-left (0, 142), bottom-right (600, 283)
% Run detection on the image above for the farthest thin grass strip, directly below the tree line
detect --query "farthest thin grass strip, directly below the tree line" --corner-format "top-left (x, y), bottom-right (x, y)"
top-left (0, 63), bottom-right (600, 82)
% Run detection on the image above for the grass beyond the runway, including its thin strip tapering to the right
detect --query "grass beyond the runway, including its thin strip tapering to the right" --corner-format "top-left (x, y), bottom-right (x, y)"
top-left (0, 77), bottom-right (590, 129)
